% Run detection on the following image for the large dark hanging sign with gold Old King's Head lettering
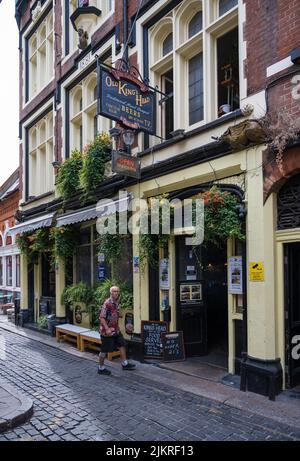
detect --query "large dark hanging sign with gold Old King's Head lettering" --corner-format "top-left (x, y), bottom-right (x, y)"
top-left (98, 64), bottom-right (156, 134)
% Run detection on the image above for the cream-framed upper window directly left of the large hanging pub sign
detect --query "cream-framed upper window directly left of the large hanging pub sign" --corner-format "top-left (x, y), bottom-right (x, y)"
top-left (69, 68), bottom-right (112, 152)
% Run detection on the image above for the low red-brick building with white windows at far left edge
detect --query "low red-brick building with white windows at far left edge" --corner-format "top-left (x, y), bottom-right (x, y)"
top-left (0, 168), bottom-right (20, 304)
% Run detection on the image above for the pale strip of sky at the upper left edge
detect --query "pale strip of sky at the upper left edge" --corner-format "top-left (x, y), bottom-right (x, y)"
top-left (0, 0), bottom-right (19, 185)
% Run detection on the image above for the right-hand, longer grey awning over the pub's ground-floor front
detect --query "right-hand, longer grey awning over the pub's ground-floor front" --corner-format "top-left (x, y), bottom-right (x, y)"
top-left (56, 195), bottom-right (132, 227)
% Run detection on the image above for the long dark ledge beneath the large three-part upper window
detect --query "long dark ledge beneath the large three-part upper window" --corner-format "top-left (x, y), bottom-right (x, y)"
top-left (138, 109), bottom-right (243, 157)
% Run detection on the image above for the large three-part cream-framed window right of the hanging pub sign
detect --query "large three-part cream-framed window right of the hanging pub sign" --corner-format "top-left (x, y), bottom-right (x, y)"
top-left (148, 0), bottom-right (240, 142)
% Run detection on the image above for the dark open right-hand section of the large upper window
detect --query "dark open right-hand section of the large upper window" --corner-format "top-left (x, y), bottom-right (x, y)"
top-left (217, 28), bottom-right (240, 116)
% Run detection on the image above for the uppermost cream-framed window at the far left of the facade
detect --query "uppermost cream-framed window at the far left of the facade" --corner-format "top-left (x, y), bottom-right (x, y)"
top-left (26, 11), bottom-right (54, 100)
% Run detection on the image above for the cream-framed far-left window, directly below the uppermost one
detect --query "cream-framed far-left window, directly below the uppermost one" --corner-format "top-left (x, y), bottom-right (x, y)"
top-left (27, 112), bottom-right (54, 196)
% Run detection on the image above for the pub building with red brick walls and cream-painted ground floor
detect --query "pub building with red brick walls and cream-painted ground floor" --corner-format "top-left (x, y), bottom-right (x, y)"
top-left (14, 0), bottom-right (300, 394)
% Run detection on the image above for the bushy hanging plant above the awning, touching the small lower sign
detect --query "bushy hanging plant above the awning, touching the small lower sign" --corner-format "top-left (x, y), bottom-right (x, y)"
top-left (80, 133), bottom-right (111, 199)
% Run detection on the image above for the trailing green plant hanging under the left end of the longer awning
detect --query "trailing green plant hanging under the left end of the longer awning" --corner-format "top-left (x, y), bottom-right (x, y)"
top-left (51, 225), bottom-right (80, 261)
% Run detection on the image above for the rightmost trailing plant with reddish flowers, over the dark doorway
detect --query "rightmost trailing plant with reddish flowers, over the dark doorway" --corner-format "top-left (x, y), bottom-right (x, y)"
top-left (200, 186), bottom-right (245, 245)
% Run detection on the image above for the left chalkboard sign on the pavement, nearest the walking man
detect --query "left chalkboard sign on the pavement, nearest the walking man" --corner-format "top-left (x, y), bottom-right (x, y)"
top-left (142, 321), bottom-right (168, 359)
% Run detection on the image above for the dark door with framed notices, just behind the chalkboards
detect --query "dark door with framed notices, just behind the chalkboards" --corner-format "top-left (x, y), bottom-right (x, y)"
top-left (176, 237), bottom-right (207, 357)
